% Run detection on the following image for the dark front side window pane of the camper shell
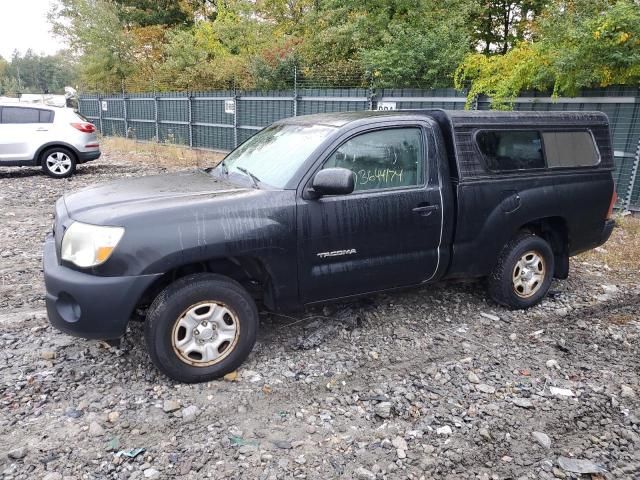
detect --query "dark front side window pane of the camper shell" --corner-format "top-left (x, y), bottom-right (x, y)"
top-left (476, 130), bottom-right (545, 171)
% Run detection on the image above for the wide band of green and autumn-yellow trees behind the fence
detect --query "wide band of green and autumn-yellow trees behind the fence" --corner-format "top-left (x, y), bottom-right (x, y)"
top-left (47, 0), bottom-right (640, 96)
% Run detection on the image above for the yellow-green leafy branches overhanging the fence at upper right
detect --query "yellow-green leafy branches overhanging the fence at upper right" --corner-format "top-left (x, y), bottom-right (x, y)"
top-left (455, 0), bottom-right (640, 108)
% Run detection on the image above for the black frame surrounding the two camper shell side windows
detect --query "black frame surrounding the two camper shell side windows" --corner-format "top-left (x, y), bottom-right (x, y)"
top-left (473, 125), bottom-right (602, 175)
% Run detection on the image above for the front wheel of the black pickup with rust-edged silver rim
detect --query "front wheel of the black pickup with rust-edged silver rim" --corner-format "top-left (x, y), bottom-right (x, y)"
top-left (144, 273), bottom-right (258, 383)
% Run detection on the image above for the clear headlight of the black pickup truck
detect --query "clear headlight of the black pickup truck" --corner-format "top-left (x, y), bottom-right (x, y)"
top-left (62, 222), bottom-right (124, 268)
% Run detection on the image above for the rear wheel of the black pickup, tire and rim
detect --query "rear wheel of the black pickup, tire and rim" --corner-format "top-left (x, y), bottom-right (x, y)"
top-left (489, 232), bottom-right (555, 309)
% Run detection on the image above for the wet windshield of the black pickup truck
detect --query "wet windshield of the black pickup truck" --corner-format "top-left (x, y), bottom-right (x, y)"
top-left (218, 124), bottom-right (335, 188)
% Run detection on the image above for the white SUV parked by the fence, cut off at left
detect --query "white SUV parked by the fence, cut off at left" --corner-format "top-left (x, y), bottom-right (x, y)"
top-left (0, 103), bottom-right (100, 178)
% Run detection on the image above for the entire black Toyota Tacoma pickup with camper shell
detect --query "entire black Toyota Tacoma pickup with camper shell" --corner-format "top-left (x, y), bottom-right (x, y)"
top-left (44, 110), bottom-right (615, 382)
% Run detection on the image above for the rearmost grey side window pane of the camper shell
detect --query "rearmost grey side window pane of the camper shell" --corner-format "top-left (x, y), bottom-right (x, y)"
top-left (542, 131), bottom-right (600, 167)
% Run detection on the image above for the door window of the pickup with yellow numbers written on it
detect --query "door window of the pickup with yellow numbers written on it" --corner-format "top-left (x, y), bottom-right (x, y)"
top-left (322, 127), bottom-right (424, 191)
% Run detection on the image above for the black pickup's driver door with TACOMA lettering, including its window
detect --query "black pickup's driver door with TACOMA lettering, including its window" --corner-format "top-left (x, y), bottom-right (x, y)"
top-left (297, 124), bottom-right (442, 304)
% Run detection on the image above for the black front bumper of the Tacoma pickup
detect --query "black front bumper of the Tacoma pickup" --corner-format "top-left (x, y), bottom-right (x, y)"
top-left (43, 235), bottom-right (160, 340)
